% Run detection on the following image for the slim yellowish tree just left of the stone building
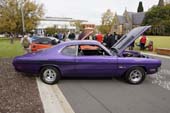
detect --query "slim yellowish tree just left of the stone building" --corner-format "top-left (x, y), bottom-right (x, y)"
top-left (99, 9), bottom-right (114, 33)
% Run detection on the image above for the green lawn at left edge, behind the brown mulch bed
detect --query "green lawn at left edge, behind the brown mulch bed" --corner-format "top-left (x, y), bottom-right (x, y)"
top-left (0, 38), bottom-right (24, 58)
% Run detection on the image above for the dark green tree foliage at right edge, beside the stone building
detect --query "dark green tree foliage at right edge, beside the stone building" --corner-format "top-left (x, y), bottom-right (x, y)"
top-left (143, 4), bottom-right (170, 35)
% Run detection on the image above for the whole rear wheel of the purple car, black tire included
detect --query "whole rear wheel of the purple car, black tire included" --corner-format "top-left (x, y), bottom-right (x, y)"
top-left (40, 66), bottom-right (61, 85)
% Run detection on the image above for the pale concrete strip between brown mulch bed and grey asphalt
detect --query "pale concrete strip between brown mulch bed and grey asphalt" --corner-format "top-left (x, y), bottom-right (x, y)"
top-left (36, 78), bottom-right (74, 113)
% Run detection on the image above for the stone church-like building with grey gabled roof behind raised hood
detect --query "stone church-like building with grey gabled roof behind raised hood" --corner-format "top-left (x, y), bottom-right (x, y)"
top-left (111, 10), bottom-right (145, 34)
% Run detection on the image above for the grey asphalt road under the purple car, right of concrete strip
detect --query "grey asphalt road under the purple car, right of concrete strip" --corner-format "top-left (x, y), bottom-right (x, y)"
top-left (58, 58), bottom-right (170, 113)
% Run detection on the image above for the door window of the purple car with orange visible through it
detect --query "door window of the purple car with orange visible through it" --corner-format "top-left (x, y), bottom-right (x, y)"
top-left (78, 45), bottom-right (109, 56)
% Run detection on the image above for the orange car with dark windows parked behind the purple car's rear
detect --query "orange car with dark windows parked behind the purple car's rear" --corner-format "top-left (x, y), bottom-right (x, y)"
top-left (31, 37), bottom-right (59, 52)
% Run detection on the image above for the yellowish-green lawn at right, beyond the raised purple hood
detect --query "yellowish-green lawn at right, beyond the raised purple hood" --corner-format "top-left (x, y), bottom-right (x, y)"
top-left (135, 36), bottom-right (170, 50)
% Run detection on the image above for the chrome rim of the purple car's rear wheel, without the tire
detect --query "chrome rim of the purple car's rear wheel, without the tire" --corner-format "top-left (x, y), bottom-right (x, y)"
top-left (43, 69), bottom-right (57, 83)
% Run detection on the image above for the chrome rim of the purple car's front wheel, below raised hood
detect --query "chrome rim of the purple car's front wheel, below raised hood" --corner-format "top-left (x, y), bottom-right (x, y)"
top-left (129, 70), bottom-right (143, 83)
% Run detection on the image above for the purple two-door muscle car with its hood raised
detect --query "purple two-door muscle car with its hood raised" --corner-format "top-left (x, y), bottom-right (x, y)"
top-left (13, 26), bottom-right (161, 84)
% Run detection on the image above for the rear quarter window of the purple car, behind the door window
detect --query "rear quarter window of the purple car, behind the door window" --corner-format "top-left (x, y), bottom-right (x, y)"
top-left (61, 46), bottom-right (77, 56)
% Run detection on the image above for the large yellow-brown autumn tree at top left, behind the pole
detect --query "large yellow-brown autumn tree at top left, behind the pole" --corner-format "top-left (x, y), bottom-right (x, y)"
top-left (0, 0), bottom-right (44, 33)
